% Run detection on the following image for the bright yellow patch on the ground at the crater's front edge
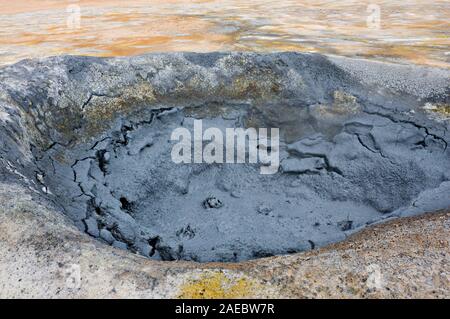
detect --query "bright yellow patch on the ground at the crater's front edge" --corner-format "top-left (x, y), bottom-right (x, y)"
top-left (178, 272), bottom-right (259, 299)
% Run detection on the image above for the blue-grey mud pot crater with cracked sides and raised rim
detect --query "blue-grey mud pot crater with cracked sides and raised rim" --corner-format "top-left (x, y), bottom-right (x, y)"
top-left (0, 53), bottom-right (450, 262)
